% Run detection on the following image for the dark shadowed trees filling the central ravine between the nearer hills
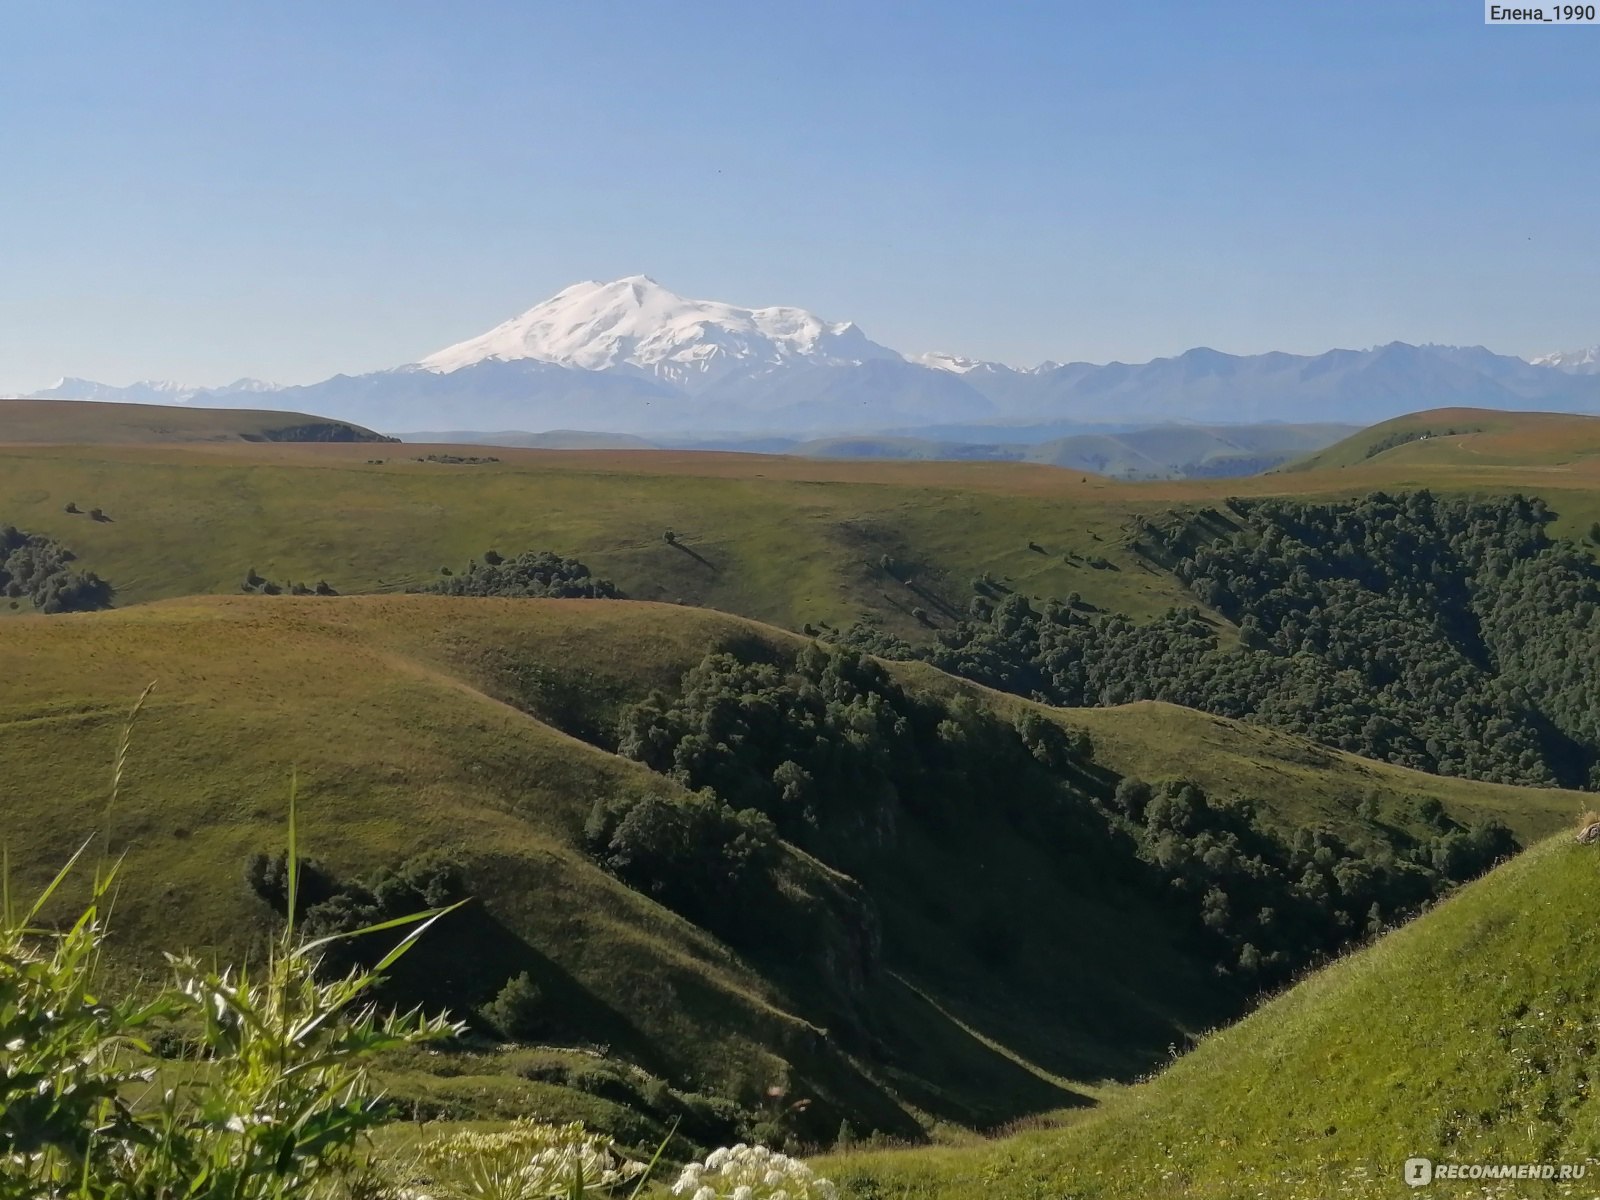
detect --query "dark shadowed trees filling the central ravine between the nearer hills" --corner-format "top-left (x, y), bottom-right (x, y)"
top-left (589, 643), bottom-right (1517, 990)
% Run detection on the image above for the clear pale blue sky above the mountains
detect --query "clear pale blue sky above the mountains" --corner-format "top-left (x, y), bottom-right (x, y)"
top-left (0, 0), bottom-right (1600, 390)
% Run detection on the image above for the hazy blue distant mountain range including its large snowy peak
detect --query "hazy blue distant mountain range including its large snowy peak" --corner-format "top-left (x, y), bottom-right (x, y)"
top-left (34, 275), bottom-right (1600, 440)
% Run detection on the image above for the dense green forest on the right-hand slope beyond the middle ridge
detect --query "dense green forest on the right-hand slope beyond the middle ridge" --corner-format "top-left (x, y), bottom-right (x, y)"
top-left (842, 491), bottom-right (1600, 787)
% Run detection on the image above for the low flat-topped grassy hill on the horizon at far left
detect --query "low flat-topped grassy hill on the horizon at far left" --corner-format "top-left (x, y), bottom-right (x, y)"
top-left (0, 400), bottom-right (379, 445)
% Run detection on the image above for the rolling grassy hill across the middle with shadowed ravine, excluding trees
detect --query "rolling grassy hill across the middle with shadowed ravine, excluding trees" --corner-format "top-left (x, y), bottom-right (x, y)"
top-left (0, 597), bottom-right (1581, 1158)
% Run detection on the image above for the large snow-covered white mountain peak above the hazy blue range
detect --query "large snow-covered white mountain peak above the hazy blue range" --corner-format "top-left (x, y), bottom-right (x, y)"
top-left (418, 275), bottom-right (901, 386)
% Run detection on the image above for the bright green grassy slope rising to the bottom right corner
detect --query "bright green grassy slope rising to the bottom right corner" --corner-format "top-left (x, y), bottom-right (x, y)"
top-left (829, 837), bottom-right (1600, 1200)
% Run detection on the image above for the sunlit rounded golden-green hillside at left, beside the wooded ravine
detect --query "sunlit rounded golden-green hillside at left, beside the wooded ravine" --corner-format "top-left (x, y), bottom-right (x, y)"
top-left (0, 600), bottom-right (838, 1126)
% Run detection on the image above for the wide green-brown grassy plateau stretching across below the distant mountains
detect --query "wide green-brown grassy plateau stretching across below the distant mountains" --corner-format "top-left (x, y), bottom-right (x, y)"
top-left (9, 402), bottom-right (1600, 634)
